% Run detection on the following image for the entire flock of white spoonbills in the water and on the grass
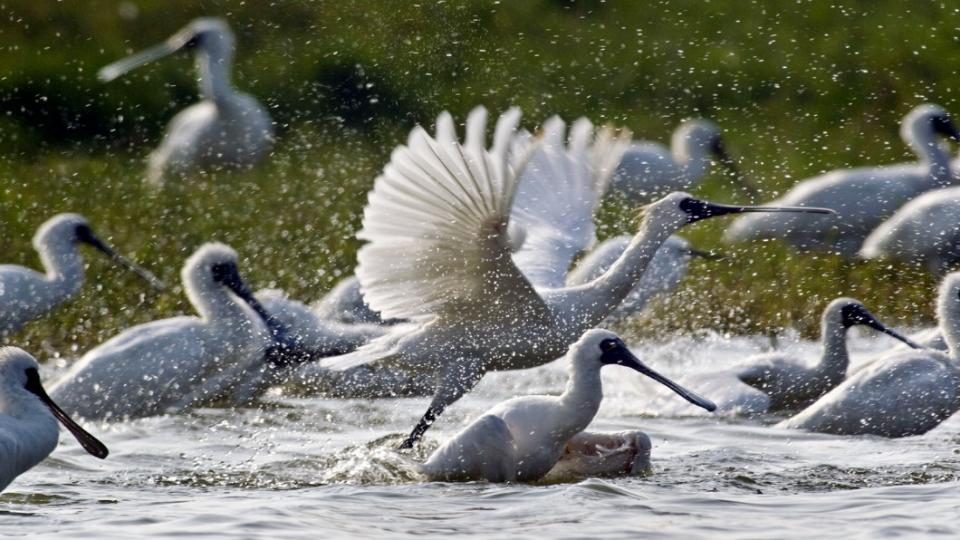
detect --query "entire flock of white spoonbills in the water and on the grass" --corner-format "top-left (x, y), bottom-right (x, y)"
top-left (0, 19), bottom-right (960, 489)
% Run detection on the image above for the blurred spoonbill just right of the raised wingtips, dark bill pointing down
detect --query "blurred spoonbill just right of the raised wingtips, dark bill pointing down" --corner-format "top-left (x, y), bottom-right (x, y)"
top-left (611, 120), bottom-right (757, 203)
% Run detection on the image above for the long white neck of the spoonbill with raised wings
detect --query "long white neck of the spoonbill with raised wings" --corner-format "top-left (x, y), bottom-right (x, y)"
top-left (544, 211), bottom-right (683, 335)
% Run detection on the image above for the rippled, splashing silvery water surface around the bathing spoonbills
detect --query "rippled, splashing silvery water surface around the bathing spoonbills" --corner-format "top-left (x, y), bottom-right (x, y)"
top-left (0, 337), bottom-right (960, 538)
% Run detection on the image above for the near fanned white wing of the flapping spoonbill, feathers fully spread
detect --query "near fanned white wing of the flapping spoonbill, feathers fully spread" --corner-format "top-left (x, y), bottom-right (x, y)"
top-left (357, 115), bottom-right (547, 319)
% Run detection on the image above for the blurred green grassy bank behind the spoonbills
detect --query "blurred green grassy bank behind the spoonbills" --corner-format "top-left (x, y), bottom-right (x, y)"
top-left (0, 0), bottom-right (960, 354)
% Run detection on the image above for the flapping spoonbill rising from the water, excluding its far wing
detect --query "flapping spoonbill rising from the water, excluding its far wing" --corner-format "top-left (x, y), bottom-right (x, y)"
top-left (310, 112), bottom-right (829, 447)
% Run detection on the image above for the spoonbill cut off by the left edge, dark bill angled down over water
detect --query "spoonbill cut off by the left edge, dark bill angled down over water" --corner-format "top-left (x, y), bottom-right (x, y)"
top-left (0, 347), bottom-right (108, 491)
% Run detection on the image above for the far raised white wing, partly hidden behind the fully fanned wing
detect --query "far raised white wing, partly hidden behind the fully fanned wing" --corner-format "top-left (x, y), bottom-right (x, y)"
top-left (511, 117), bottom-right (629, 288)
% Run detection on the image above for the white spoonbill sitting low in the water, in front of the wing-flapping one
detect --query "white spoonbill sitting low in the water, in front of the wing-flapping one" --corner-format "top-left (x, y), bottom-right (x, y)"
top-left (422, 330), bottom-right (715, 482)
